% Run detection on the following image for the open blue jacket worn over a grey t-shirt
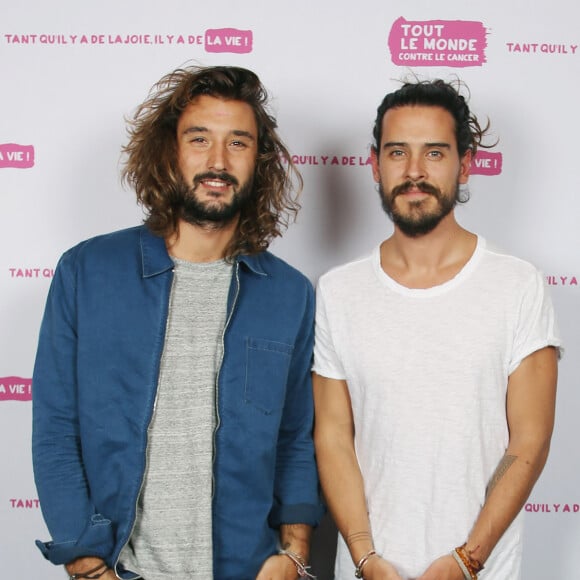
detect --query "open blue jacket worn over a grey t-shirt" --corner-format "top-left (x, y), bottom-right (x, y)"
top-left (32, 226), bottom-right (321, 580)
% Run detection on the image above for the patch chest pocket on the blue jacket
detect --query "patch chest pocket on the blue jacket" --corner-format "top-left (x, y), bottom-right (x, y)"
top-left (244, 337), bottom-right (294, 415)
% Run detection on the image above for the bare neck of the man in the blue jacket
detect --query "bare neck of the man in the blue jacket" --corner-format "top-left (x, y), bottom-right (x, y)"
top-left (165, 219), bottom-right (238, 262)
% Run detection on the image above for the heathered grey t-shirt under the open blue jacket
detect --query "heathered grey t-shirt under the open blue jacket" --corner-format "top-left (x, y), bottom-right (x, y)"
top-left (120, 258), bottom-right (232, 580)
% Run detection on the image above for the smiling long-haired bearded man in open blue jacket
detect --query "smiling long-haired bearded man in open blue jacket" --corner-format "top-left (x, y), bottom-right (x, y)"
top-left (33, 67), bottom-right (321, 580)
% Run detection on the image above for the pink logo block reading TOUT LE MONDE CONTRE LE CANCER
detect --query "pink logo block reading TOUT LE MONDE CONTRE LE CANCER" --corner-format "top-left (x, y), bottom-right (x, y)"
top-left (389, 17), bottom-right (487, 67)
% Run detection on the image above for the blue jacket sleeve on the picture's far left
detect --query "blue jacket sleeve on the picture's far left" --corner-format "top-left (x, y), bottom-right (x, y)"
top-left (32, 258), bottom-right (95, 552)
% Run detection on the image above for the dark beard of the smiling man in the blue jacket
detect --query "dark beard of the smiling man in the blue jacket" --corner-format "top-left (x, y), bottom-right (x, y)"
top-left (176, 171), bottom-right (254, 228)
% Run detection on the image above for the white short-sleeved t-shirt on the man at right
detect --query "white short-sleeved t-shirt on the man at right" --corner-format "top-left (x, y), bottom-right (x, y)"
top-left (314, 237), bottom-right (561, 580)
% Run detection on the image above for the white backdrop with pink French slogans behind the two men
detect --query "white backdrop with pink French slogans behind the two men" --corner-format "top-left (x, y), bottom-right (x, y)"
top-left (0, 0), bottom-right (580, 580)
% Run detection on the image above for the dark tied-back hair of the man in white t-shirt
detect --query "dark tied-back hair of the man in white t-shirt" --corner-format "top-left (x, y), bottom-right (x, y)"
top-left (372, 79), bottom-right (496, 157)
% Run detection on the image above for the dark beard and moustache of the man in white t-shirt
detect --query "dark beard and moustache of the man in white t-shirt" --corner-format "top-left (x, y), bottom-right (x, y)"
top-left (379, 181), bottom-right (459, 238)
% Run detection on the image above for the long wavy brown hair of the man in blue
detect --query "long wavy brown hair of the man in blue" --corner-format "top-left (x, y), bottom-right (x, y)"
top-left (122, 66), bottom-right (303, 258)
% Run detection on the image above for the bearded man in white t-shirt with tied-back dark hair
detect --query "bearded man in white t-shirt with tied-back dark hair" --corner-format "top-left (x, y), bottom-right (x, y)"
top-left (314, 80), bottom-right (561, 580)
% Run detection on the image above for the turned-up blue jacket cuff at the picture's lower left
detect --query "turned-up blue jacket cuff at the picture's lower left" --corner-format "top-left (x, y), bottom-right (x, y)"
top-left (36, 515), bottom-right (115, 565)
